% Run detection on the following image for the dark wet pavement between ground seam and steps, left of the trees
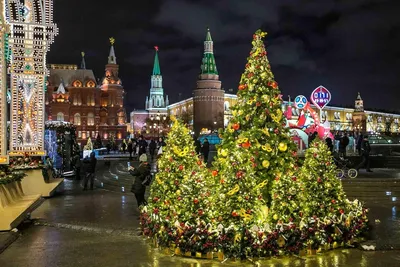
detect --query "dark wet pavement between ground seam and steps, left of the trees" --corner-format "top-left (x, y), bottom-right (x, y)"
top-left (31, 181), bottom-right (139, 232)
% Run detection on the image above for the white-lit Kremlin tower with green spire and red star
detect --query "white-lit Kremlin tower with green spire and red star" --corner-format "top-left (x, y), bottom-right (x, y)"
top-left (145, 46), bottom-right (168, 112)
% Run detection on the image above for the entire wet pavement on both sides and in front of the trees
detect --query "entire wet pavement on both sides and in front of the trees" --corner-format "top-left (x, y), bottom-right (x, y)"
top-left (0, 161), bottom-right (400, 267)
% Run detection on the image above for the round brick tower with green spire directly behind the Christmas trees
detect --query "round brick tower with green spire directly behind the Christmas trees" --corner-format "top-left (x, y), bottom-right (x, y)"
top-left (193, 29), bottom-right (224, 135)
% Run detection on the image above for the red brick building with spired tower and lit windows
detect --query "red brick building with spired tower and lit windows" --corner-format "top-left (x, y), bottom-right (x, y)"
top-left (45, 44), bottom-right (127, 146)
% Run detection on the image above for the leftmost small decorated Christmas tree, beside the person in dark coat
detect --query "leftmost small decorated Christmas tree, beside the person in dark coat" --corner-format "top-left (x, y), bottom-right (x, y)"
top-left (141, 118), bottom-right (212, 250)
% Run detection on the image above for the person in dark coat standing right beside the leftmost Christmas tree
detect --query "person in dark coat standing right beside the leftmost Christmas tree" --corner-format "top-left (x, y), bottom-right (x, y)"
top-left (128, 154), bottom-right (150, 207)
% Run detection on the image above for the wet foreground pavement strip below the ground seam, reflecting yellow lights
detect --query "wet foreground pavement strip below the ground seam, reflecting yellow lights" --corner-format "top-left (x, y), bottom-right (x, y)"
top-left (0, 226), bottom-right (400, 267)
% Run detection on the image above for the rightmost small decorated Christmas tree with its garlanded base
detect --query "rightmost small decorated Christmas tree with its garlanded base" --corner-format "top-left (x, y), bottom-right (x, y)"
top-left (299, 138), bottom-right (367, 248)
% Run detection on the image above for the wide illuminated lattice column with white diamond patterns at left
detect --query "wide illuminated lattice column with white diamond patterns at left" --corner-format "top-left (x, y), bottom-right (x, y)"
top-left (3, 0), bottom-right (58, 156)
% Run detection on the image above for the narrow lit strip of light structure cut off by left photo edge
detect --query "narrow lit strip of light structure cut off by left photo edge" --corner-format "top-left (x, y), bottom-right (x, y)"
top-left (0, 0), bottom-right (9, 164)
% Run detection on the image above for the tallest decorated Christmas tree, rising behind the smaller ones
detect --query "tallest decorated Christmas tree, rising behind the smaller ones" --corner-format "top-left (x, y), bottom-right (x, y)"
top-left (217, 30), bottom-right (298, 219)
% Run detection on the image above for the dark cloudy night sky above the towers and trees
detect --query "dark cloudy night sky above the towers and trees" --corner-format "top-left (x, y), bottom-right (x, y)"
top-left (48, 0), bottom-right (400, 112)
